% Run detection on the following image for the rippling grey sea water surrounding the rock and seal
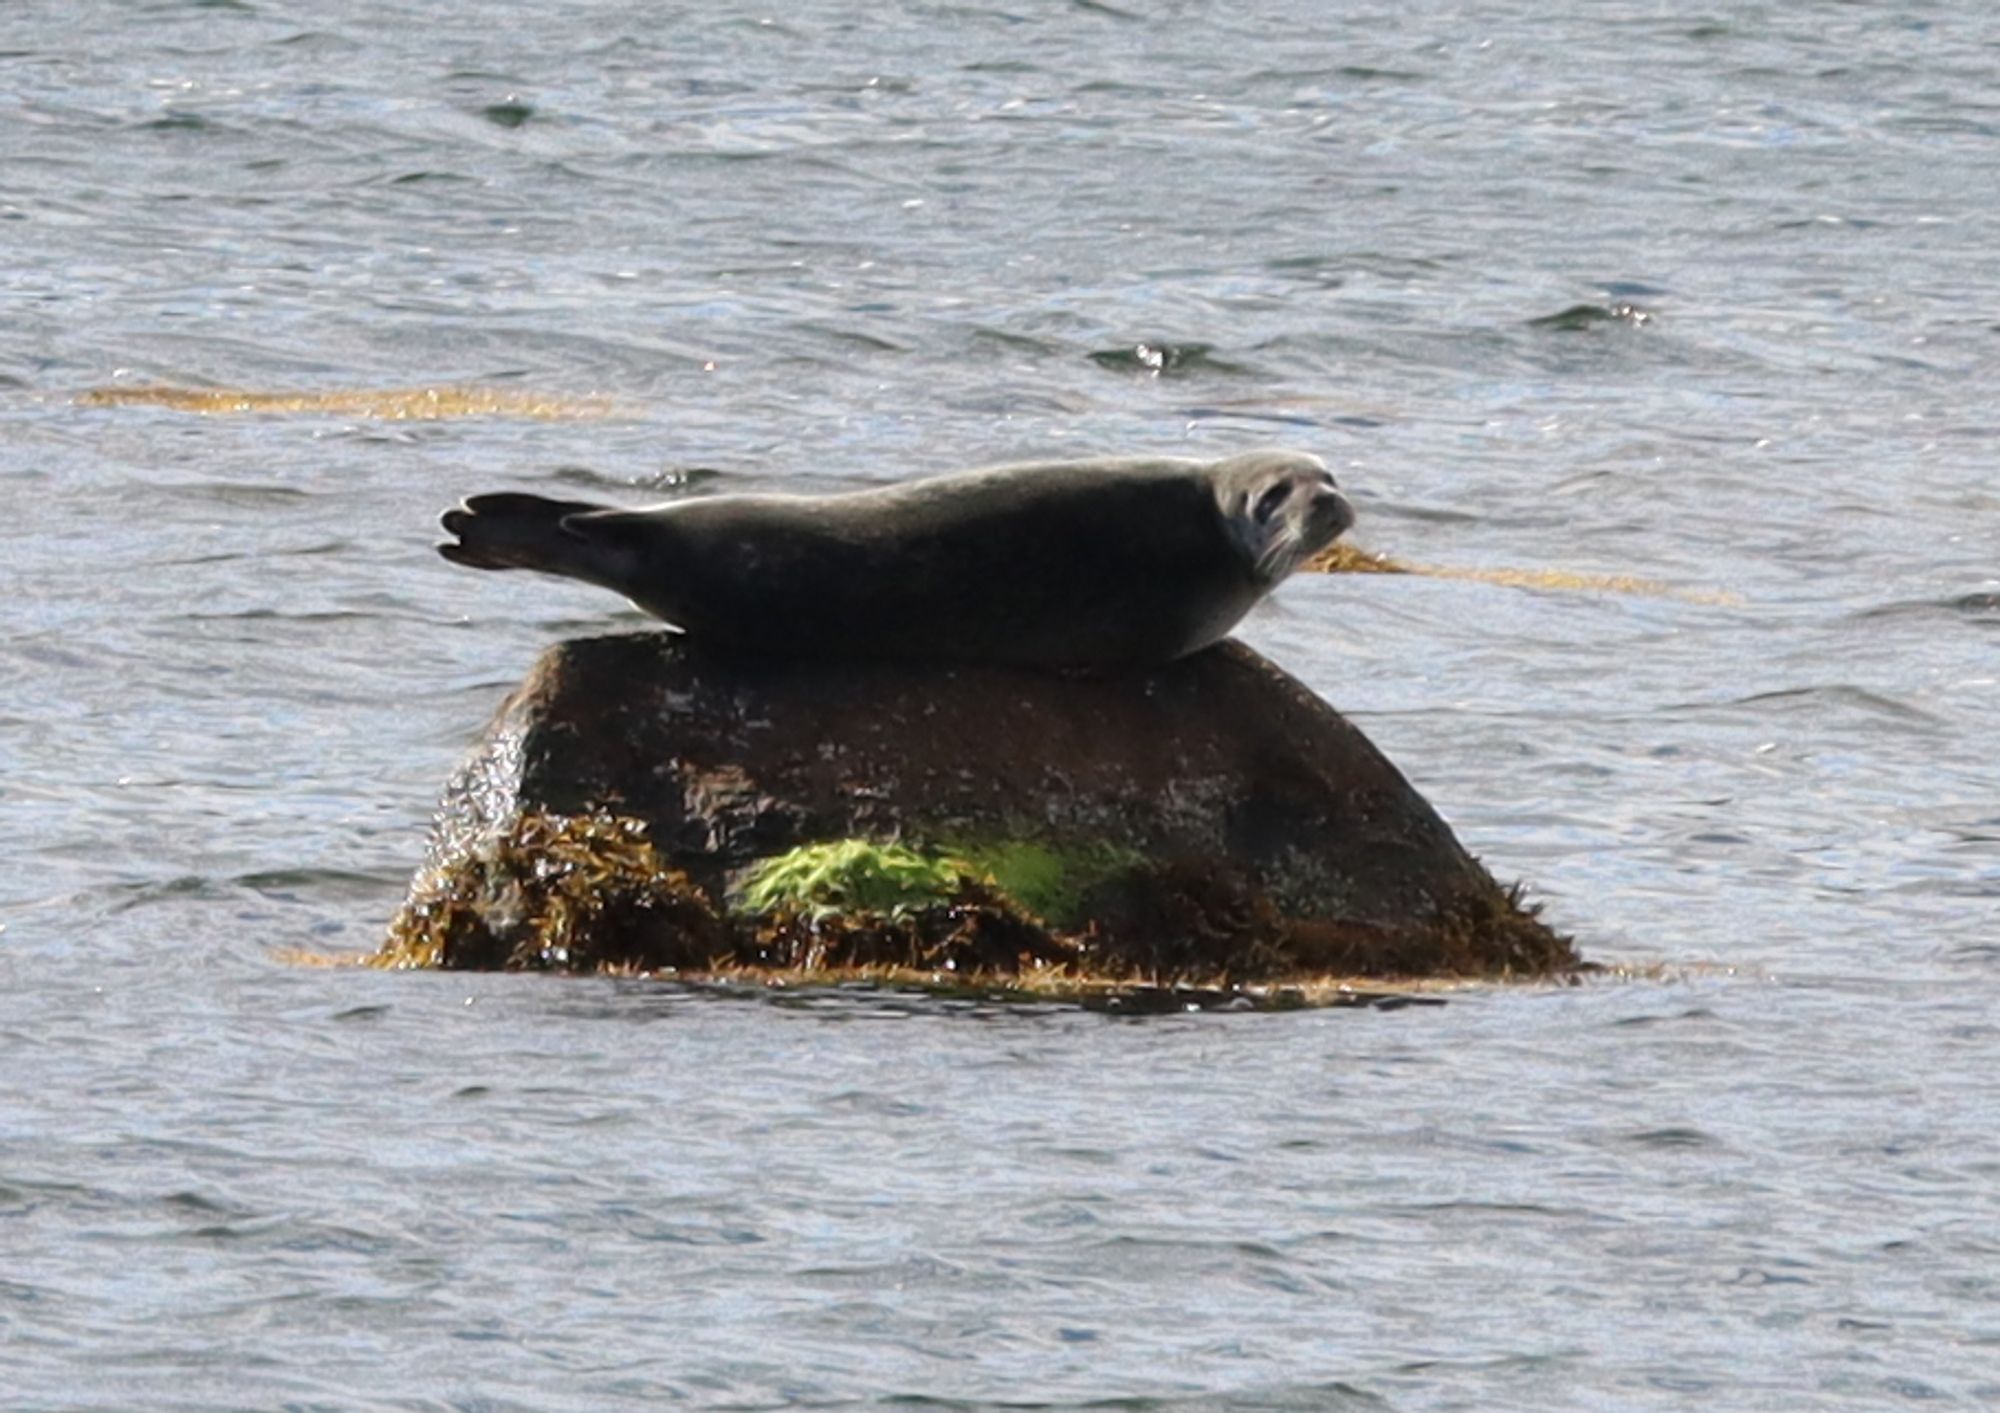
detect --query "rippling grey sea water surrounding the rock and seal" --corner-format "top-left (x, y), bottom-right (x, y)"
top-left (0, 0), bottom-right (2000, 1411)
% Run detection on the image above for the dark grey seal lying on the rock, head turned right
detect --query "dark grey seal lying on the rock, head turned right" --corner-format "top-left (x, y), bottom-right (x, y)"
top-left (438, 450), bottom-right (1354, 666)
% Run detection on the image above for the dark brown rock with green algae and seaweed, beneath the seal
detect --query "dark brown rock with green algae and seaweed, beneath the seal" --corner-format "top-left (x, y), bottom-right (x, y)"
top-left (384, 632), bottom-right (1580, 985)
